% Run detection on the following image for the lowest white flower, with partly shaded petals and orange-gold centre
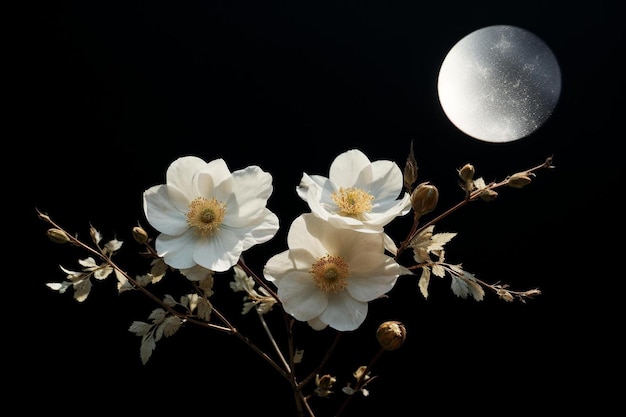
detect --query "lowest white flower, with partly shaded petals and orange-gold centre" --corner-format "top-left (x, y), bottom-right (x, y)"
top-left (263, 213), bottom-right (411, 331)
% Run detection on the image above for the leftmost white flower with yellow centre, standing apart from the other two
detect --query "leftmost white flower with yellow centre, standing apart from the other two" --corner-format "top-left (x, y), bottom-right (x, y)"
top-left (143, 156), bottom-right (278, 272)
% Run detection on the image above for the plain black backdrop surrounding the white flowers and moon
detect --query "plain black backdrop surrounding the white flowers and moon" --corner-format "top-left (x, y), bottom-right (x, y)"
top-left (15, 1), bottom-right (624, 417)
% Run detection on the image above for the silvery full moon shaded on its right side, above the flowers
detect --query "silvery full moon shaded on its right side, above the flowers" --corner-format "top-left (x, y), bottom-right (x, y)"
top-left (437, 25), bottom-right (561, 142)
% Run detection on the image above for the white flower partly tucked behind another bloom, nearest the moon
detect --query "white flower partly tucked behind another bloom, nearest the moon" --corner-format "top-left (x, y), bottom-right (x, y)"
top-left (296, 149), bottom-right (411, 233)
